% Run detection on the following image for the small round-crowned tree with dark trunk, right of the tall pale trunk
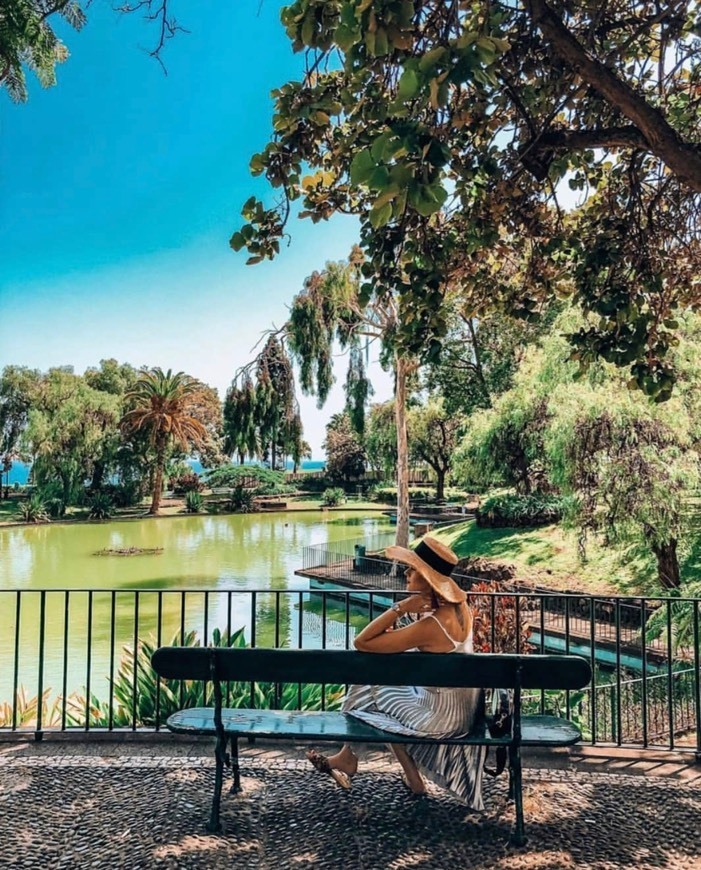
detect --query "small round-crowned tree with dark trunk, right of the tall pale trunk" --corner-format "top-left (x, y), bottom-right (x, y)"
top-left (409, 399), bottom-right (465, 499)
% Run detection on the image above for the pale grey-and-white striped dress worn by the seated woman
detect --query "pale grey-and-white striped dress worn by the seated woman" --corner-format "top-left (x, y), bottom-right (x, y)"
top-left (342, 616), bottom-right (486, 810)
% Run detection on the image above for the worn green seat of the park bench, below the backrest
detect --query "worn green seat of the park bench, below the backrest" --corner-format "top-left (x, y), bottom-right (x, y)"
top-left (167, 707), bottom-right (582, 746)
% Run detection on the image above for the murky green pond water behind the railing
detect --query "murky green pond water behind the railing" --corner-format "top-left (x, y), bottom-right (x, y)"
top-left (0, 511), bottom-right (391, 717)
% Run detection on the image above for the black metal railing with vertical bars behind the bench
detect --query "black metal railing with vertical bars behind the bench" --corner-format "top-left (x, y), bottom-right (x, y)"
top-left (0, 588), bottom-right (701, 754)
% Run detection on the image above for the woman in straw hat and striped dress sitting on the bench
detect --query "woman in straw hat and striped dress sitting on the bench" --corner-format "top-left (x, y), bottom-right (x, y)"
top-left (307, 536), bottom-right (485, 809)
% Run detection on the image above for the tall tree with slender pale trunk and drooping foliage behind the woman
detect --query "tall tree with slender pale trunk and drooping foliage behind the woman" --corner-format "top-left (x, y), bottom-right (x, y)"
top-left (286, 255), bottom-right (417, 546)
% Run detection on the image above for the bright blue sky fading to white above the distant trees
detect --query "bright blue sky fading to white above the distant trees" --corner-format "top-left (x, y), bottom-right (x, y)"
top-left (0, 0), bottom-right (390, 457)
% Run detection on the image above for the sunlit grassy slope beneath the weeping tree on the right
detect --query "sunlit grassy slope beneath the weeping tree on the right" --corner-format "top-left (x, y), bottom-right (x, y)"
top-left (435, 521), bottom-right (644, 594)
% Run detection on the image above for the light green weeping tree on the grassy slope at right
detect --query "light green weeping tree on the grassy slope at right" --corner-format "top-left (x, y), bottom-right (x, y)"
top-left (456, 310), bottom-right (701, 594)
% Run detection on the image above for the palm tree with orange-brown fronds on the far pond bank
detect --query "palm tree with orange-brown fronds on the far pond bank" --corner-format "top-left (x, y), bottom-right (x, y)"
top-left (120, 368), bottom-right (207, 514)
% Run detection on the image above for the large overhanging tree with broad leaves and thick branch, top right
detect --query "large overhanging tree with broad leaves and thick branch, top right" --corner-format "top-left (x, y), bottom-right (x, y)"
top-left (231, 0), bottom-right (701, 400)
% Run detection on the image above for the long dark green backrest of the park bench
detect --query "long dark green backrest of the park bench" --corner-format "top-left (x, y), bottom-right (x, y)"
top-left (151, 647), bottom-right (591, 689)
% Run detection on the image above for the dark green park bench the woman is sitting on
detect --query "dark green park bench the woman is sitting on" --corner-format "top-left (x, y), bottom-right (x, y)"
top-left (152, 647), bottom-right (591, 845)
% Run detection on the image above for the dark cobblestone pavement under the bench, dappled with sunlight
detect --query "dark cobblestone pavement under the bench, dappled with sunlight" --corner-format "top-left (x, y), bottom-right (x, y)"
top-left (0, 744), bottom-right (701, 870)
